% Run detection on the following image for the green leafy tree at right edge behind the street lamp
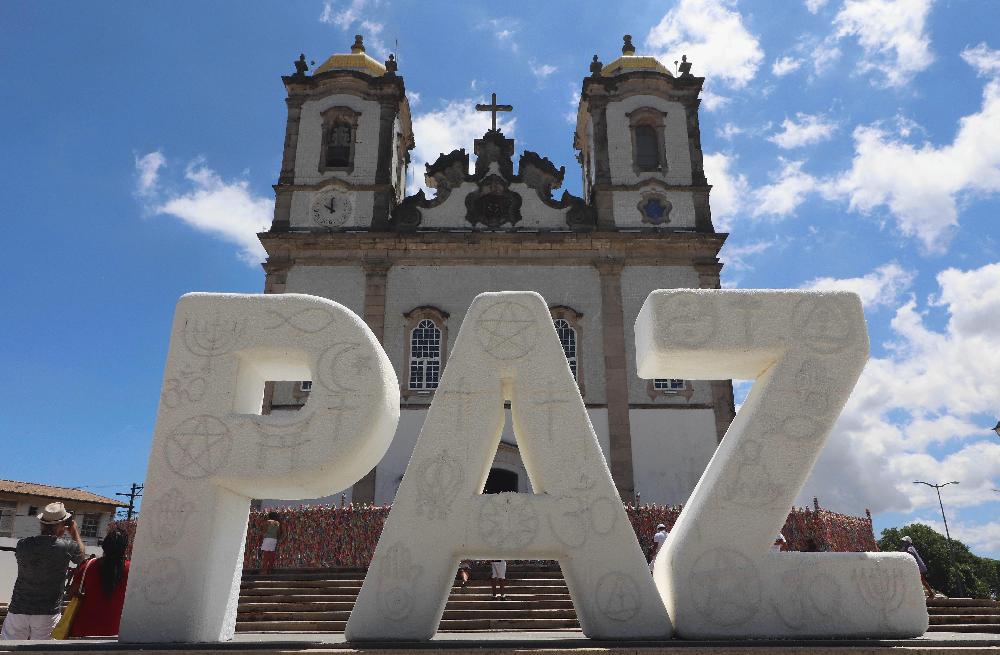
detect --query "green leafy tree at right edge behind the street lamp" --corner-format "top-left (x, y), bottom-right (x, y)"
top-left (878, 523), bottom-right (1000, 599)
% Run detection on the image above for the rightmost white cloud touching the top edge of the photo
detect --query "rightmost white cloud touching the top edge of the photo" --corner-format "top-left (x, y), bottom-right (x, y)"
top-left (833, 0), bottom-right (934, 87)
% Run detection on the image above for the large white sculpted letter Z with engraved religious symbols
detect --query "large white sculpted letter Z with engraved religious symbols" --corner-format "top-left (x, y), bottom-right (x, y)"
top-left (635, 290), bottom-right (927, 639)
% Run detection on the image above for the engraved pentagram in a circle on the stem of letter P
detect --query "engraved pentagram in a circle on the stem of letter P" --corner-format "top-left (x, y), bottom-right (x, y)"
top-left (165, 415), bottom-right (233, 480)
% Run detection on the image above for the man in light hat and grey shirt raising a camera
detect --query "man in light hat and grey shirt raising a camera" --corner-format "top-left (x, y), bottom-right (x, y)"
top-left (0, 503), bottom-right (87, 639)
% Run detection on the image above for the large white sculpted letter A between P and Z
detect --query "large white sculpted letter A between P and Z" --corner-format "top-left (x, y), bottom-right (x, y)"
top-left (346, 292), bottom-right (671, 640)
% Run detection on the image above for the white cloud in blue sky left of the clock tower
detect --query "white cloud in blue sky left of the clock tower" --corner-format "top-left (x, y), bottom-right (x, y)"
top-left (136, 152), bottom-right (274, 264)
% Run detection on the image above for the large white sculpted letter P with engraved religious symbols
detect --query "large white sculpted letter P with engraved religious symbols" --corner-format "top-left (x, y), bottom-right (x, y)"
top-left (121, 293), bottom-right (399, 642)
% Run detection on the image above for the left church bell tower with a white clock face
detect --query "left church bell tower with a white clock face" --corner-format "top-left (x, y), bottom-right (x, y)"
top-left (271, 35), bottom-right (413, 232)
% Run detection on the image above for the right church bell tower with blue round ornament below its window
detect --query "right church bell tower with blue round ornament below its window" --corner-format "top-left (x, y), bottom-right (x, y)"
top-left (574, 35), bottom-right (714, 232)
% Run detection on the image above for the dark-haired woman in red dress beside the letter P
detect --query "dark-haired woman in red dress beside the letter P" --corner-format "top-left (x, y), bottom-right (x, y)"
top-left (69, 528), bottom-right (128, 637)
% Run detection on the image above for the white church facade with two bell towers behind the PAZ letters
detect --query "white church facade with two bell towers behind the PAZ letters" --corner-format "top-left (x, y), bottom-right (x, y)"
top-left (260, 36), bottom-right (734, 504)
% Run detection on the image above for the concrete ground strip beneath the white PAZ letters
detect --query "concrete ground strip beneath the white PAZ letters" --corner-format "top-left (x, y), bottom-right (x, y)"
top-left (0, 632), bottom-right (1000, 655)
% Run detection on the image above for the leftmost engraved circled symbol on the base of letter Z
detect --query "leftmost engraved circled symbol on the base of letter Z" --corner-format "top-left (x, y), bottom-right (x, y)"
top-left (690, 548), bottom-right (761, 626)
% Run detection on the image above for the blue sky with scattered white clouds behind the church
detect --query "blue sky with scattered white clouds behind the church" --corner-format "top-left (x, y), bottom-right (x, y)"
top-left (0, 0), bottom-right (1000, 557)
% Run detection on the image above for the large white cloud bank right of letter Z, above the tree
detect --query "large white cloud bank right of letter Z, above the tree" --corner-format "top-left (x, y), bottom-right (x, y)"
top-left (801, 263), bottom-right (1000, 516)
